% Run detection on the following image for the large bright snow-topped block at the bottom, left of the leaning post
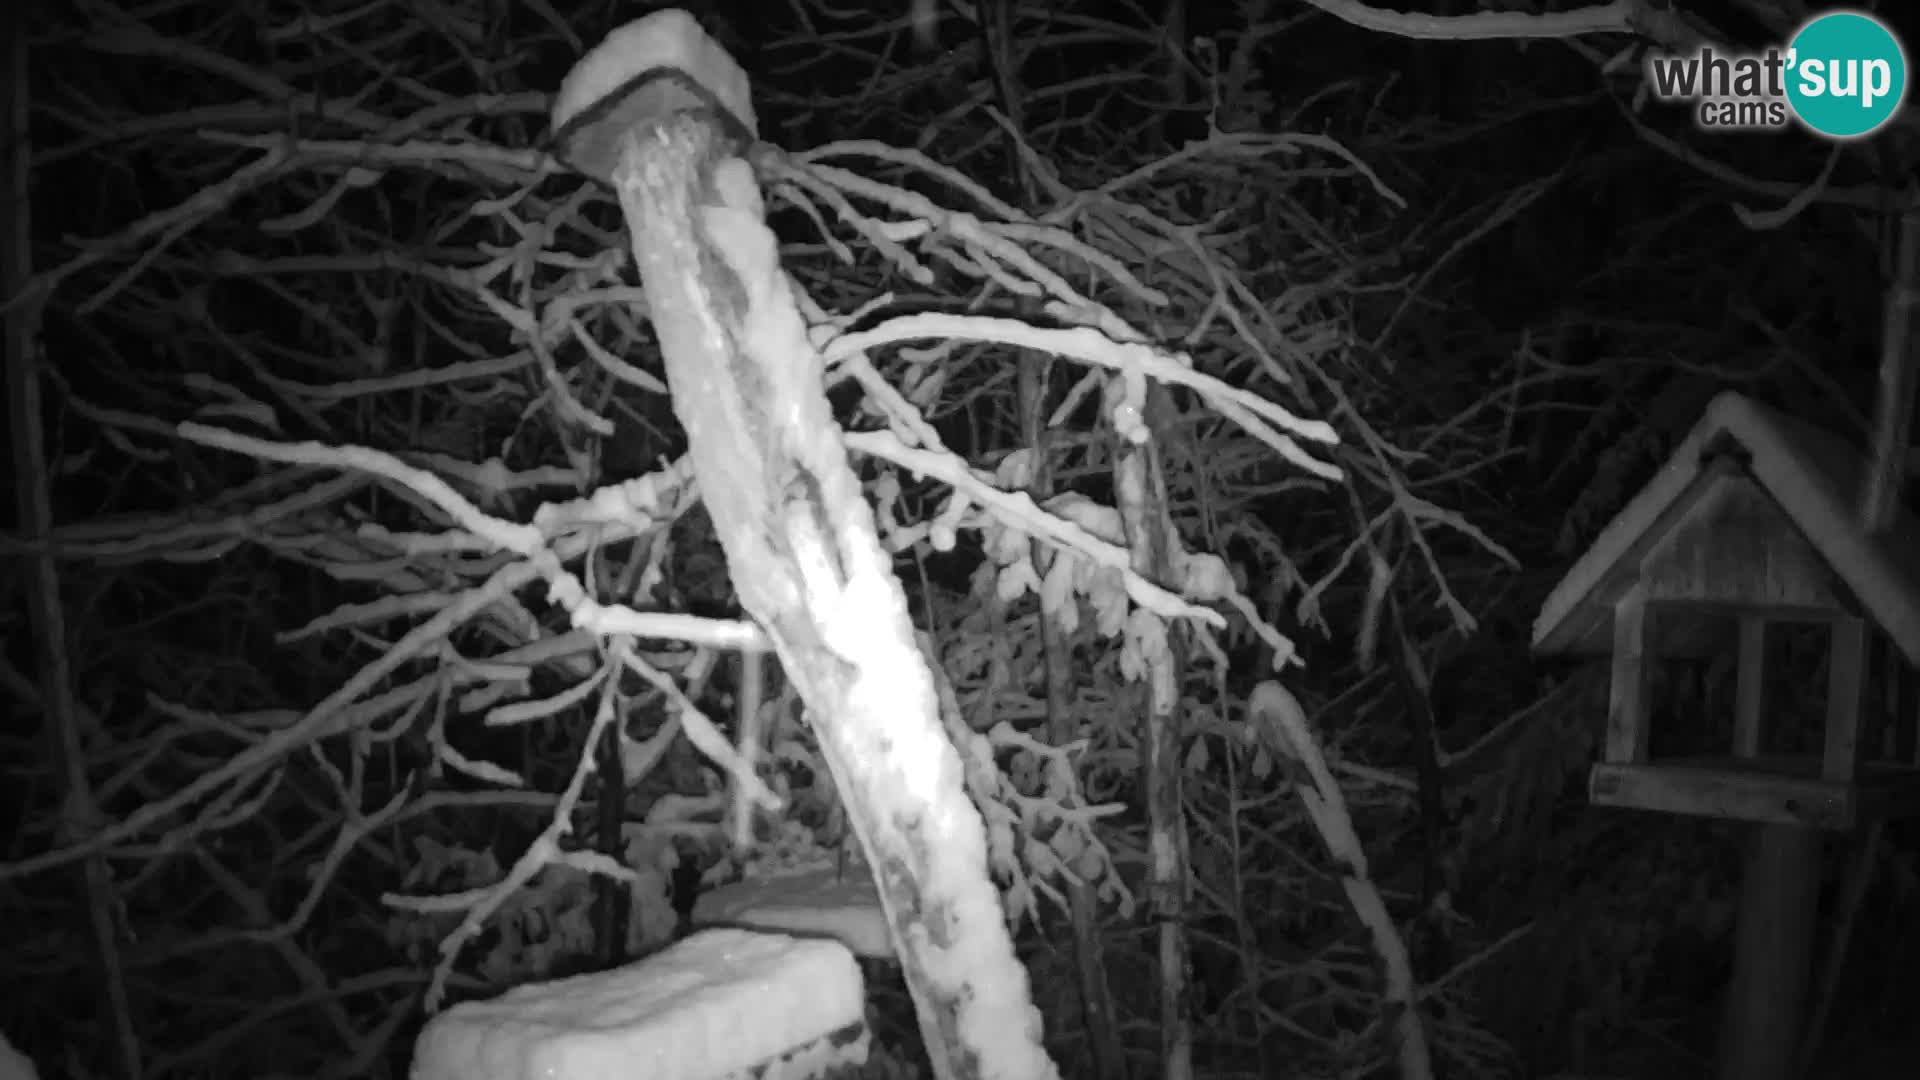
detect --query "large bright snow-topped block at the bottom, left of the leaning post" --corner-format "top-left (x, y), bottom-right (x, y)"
top-left (413, 928), bottom-right (870, 1080)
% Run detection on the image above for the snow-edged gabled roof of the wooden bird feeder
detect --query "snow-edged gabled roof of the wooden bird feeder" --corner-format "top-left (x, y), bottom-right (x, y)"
top-left (1534, 392), bottom-right (1920, 667)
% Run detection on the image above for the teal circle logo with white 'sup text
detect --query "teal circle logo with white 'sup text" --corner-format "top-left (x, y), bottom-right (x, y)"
top-left (1788, 12), bottom-right (1907, 138)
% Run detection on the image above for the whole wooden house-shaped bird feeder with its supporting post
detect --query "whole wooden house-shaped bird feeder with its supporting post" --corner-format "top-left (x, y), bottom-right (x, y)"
top-left (1534, 394), bottom-right (1920, 1080)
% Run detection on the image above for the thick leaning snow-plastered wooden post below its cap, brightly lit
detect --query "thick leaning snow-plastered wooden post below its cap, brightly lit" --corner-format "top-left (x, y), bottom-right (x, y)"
top-left (616, 111), bottom-right (1056, 1080)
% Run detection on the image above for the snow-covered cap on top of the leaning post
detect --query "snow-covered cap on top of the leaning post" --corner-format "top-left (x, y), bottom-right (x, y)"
top-left (553, 8), bottom-right (758, 181)
